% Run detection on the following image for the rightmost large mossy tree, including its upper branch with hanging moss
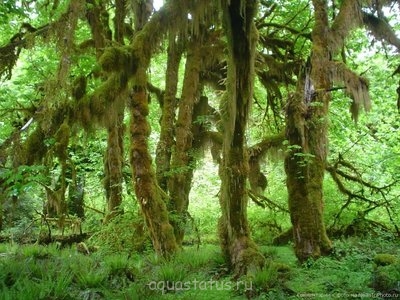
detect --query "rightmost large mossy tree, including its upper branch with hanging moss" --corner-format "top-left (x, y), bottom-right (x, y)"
top-left (285, 0), bottom-right (397, 261)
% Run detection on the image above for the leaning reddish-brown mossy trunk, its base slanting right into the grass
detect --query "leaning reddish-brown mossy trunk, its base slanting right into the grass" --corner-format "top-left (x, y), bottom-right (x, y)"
top-left (129, 0), bottom-right (178, 257)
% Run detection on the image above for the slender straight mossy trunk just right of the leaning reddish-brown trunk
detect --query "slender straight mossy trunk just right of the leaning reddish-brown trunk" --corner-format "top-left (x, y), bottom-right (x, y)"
top-left (168, 37), bottom-right (201, 245)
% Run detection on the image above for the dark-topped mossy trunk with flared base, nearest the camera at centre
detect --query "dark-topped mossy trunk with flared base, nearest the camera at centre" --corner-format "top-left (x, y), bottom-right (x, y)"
top-left (219, 0), bottom-right (264, 276)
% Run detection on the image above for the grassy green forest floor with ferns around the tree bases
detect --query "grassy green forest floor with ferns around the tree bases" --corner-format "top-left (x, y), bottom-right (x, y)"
top-left (0, 237), bottom-right (400, 300)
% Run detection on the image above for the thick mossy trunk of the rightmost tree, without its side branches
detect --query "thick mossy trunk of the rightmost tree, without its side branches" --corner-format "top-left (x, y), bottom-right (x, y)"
top-left (285, 0), bottom-right (332, 261)
